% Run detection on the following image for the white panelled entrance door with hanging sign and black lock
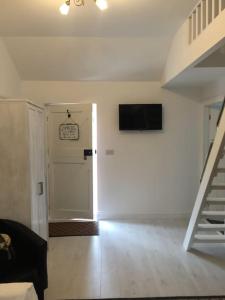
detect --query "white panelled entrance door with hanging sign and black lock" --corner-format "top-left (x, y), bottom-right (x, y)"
top-left (47, 104), bottom-right (95, 220)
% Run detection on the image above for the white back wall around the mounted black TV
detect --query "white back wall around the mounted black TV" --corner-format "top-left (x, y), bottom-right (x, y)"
top-left (22, 81), bottom-right (201, 217)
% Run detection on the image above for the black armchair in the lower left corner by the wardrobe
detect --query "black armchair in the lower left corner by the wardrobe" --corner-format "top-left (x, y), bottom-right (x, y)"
top-left (0, 219), bottom-right (48, 300)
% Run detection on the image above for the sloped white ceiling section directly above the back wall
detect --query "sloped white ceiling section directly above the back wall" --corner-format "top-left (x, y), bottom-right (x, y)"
top-left (5, 37), bottom-right (169, 81)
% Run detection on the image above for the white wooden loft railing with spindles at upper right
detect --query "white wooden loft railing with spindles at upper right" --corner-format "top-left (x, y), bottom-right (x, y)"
top-left (189, 0), bottom-right (225, 44)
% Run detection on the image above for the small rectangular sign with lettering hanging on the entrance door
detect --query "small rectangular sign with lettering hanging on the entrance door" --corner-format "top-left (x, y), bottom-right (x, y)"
top-left (59, 123), bottom-right (80, 141)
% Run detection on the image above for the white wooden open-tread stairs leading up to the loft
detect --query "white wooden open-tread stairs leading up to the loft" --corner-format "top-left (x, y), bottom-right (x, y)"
top-left (183, 101), bottom-right (225, 251)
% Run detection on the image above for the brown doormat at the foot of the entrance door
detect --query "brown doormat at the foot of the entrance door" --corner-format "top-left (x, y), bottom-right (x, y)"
top-left (49, 221), bottom-right (99, 237)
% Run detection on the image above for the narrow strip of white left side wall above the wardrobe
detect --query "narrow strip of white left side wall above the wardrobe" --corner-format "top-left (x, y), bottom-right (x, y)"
top-left (0, 38), bottom-right (21, 98)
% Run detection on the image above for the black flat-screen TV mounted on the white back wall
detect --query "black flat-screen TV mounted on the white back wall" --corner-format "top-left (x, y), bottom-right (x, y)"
top-left (119, 104), bottom-right (162, 130)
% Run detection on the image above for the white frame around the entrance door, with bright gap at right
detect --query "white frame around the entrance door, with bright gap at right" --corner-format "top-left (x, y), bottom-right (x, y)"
top-left (44, 102), bottom-right (98, 222)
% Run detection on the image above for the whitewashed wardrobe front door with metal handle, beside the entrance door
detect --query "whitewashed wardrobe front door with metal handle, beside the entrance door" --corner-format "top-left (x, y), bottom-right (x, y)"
top-left (28, 106), bottom-right (48, 240)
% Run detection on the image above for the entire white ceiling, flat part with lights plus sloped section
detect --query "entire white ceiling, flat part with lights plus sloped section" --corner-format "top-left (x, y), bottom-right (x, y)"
top-left (0, 0), bottom-right (197, 80)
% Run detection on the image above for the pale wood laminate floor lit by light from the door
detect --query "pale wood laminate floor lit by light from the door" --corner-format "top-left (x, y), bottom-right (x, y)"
top-left (46, 220), bottom-right (225, 300)
